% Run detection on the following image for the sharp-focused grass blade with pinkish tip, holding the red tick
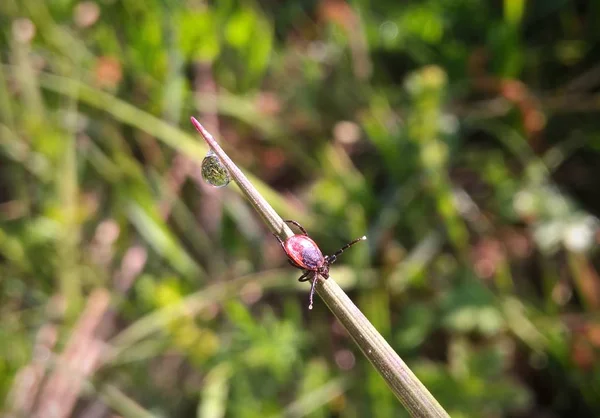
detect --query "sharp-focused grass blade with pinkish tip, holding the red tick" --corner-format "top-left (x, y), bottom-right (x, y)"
top-left (191, 117), bottom-right (448, 417)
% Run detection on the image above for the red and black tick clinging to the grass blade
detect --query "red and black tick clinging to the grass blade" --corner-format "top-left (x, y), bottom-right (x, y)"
top-left (273, 220), bottom-right (367, 309)
